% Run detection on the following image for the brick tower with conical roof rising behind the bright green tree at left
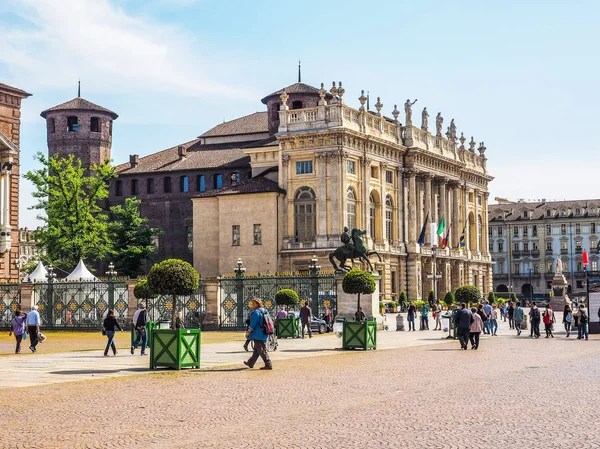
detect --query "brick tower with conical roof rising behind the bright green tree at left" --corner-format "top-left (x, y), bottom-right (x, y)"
top-left (40, 86), bottom-right (118, 167)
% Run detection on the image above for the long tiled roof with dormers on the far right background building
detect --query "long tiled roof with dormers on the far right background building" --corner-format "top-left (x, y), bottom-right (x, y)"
top-left (488, 199), bottom-right (600, 222)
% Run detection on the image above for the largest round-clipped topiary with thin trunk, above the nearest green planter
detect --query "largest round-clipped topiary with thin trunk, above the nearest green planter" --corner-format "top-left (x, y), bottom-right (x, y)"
top-left (148, 259), bottom-right (200, 329)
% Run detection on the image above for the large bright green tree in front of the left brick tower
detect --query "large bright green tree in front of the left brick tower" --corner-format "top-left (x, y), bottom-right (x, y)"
top-left (25, 153), bottom-right (116, 270)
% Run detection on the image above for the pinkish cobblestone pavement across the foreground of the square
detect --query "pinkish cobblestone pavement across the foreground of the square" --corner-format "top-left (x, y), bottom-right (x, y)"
top-left (0, 330), bottom-right (600, 449)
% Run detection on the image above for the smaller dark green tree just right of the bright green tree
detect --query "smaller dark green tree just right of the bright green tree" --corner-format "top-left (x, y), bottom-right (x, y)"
top-left (109, 198), bottom-right (162, 278)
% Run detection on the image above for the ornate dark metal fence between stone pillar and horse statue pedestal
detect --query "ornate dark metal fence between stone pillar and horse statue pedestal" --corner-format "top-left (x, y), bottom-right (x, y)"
top-left (219, 274), bottom-right (337, 329)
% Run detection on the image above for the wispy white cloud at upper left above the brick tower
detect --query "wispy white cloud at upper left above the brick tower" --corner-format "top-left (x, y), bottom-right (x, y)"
top-left (0, 0), bottom-right (257, 100)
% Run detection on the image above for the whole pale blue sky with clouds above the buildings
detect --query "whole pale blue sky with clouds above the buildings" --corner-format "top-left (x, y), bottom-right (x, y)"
top-left (0, 0), bottom-right (600, 227)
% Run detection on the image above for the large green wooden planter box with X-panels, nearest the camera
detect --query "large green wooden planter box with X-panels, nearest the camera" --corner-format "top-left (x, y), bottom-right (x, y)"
top-left (150, 329), bottom-right (200, 369)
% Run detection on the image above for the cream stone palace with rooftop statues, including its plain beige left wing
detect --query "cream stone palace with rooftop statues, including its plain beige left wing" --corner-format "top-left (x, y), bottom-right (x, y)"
top-left (192, 82), bottom-right (493, 299)
